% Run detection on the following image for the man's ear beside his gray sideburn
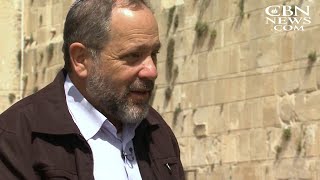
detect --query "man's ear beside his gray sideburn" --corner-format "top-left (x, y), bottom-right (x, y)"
top-left (69, 42), bottom-right (91, 78)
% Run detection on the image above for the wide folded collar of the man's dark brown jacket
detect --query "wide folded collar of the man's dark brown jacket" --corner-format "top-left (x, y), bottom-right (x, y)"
top-left (31, 69), bottom-right (161, 135)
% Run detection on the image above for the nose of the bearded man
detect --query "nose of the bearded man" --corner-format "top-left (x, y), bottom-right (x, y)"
top-left (138, 56), bottom-right (158, 80)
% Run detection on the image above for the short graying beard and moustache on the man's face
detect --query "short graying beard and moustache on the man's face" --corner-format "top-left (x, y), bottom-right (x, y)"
top-left (86, 63), bottom-right (154, 124)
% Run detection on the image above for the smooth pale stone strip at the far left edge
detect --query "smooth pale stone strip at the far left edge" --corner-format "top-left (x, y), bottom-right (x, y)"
top-left (0, 0), bottom-right (22, 112)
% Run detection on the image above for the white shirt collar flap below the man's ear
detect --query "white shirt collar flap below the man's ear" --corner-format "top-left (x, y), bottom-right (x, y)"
top-left (64, 75), bottom-right (108, 140)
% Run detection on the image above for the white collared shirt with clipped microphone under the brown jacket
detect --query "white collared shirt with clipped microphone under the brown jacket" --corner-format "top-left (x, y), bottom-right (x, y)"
top-left (64, 75), bottom-right (142, 180)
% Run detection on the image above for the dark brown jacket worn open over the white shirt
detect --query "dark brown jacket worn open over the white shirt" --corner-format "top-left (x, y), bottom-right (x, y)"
top-left (0, 72), bottom-right (184, 180)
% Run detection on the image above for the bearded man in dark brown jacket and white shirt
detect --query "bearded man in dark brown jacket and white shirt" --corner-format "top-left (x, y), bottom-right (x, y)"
top-left (0, 0), bottom-right (184, 180)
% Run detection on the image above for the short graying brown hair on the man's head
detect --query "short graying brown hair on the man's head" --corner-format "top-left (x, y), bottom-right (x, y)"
top-left (62, 0), bottom-right (149, 72)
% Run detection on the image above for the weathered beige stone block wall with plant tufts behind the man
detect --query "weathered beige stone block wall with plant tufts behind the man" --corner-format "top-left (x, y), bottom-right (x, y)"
top-left (0, 0), bottom-right (320, 180)
